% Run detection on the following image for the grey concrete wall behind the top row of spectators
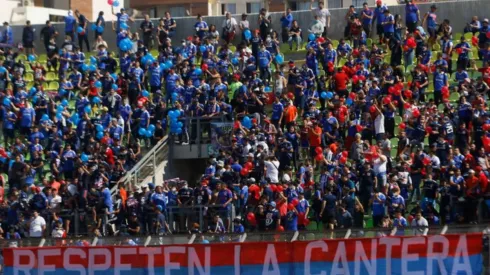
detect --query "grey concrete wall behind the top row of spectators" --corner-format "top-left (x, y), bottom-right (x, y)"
top-left (7, 0), bottom-right (490, 51)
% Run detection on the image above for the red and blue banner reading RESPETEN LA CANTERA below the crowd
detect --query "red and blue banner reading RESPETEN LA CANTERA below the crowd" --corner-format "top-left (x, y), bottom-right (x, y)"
top-left (3, 233), bottom-right (484, 275)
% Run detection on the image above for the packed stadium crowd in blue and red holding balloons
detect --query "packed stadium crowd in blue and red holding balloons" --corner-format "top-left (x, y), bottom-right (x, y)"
top-left (0, 0), bottom-right (490, 243)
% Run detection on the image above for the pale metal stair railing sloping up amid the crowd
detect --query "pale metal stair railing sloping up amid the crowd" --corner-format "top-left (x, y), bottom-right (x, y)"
top-left (111, 136), bottom-right (168, 195)
